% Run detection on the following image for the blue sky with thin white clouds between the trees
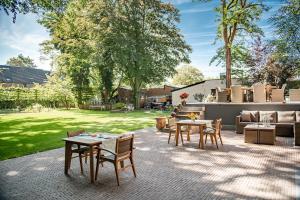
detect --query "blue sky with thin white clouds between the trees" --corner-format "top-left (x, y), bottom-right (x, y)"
top-left (0, 0), bottom-right (282, 78)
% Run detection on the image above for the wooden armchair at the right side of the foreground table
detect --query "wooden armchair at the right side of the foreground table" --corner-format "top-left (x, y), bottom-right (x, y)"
top-left (95, 135), bottom-right (136, 186)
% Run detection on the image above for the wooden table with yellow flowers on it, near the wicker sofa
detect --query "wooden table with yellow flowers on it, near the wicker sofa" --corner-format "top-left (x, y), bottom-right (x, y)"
top-left (175, 120), bottom-right (213, 149)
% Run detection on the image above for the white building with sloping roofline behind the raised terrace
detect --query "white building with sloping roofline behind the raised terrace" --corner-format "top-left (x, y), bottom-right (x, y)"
top-left (172, 79), bottom-right (239, 105)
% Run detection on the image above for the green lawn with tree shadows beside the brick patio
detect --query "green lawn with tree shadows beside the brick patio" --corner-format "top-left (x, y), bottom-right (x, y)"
top-left (0, 110), bottom-right (166, 160)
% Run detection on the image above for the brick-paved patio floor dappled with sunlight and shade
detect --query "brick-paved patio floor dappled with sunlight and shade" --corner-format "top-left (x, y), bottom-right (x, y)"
top-left (0, 128), bottom-right (300, 200)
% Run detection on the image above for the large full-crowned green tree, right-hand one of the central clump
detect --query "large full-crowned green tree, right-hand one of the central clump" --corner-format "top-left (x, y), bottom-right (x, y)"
top-left (113, 0), bottom-right (191, 107)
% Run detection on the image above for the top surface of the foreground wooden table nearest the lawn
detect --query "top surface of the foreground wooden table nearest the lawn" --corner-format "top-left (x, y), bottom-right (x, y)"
top-left (62, 133), bottom-right (120, 146)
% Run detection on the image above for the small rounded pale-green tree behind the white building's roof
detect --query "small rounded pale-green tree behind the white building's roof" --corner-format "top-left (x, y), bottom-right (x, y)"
top-left (172, 65), bottom-right (204, 85)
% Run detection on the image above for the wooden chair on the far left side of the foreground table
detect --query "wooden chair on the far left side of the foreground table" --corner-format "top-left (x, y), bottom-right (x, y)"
top-left (67, 130), bottom-right (89, 174)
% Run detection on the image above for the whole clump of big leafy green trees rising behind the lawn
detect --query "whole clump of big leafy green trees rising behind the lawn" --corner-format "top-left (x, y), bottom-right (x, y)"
top-left (40, 0), bottom-right (191, 107)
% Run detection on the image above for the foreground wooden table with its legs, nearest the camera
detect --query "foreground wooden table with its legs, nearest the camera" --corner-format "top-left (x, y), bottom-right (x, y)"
top-left (63, 135), bottom-right (117, 183)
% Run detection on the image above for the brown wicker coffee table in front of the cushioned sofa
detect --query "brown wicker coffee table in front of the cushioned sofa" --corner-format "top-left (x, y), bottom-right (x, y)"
top-left (244, 124), bottom-right (276, 144)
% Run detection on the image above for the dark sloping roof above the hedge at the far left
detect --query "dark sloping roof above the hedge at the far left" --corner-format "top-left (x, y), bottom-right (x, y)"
top-left (0, 65), bottom-right (50, 84)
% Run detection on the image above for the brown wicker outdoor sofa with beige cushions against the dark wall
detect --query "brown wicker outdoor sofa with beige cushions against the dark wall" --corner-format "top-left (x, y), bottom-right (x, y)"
top-left (236, 111), bottom-right (300, 146)
